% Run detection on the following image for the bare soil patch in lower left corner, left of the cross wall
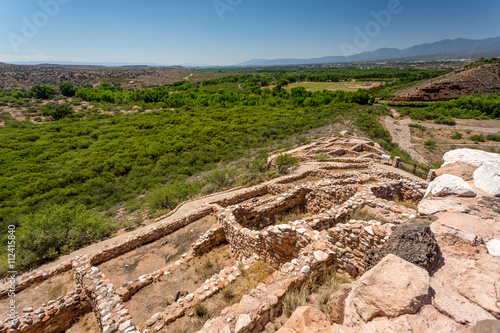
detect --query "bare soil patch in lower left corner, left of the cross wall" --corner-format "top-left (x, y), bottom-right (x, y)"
top-left (0, 271), bottom-right (75, 319)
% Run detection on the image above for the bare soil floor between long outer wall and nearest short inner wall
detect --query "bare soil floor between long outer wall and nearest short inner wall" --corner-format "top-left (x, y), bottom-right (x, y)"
top-left (98, 215), bottom-right (215, 288)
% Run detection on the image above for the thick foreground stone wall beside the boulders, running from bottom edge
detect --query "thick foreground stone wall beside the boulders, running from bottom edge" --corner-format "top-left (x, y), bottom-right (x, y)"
top-left (199, 221), bottom-right (390, 333)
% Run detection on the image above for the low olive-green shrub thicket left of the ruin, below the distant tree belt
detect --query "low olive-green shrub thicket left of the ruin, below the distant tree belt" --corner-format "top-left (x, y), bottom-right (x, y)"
top-left (0, 98), bottom-right (378, 267)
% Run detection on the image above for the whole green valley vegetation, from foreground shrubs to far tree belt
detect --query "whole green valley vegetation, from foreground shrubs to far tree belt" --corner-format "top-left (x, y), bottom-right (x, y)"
top-left (0, 65), bottom-right (456, 269)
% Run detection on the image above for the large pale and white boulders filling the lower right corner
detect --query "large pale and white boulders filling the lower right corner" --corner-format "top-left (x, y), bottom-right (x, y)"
top-left (278, 149), bottom-right (500, 333)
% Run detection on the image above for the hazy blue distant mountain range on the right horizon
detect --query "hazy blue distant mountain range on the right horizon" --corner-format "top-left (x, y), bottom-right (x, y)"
top-left (235, 37), bottom-right (500, 66)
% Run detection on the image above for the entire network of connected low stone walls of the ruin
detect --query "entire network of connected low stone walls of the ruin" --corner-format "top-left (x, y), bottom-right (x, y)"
top-left (0, 135), bottom-right (426, 332)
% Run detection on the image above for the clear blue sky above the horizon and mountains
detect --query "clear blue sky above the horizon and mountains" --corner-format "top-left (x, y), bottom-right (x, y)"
top-left (0, 0), bottom-right (500, 65)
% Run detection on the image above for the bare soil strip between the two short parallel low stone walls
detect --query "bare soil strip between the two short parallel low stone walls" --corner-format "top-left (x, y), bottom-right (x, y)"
top-left (126, 245), bottom-right (236, 323)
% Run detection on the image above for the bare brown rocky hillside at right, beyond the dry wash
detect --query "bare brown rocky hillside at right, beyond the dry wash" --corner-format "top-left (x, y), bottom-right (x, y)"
top-left (396, 63), bottom-right (500, 101)
